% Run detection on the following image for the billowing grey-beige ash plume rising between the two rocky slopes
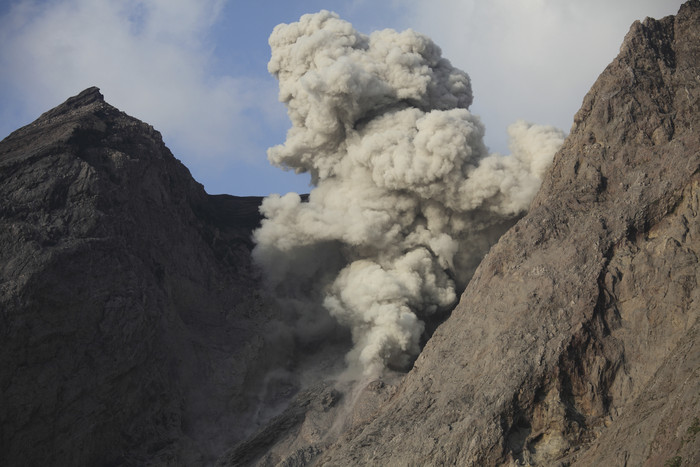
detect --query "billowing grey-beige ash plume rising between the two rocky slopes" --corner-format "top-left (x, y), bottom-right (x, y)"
top-left (254, 11), bottom-right (564, 376)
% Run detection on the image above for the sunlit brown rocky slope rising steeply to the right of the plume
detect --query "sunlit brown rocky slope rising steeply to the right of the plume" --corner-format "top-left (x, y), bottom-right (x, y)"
top-left (315, 0), bottom-right (700, 465)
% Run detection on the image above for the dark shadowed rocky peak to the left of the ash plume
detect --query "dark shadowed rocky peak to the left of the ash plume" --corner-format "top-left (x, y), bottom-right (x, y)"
top-left (0, 88), bottom-right (273, 466)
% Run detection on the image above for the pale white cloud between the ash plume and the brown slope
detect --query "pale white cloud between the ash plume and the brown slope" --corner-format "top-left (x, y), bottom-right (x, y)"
top-left (404, 0), bottom-right (682, 151)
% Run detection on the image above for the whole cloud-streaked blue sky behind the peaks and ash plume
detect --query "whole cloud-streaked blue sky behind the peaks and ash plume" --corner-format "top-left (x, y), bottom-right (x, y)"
top-left (0, 0), bottom-right (682, 195)
